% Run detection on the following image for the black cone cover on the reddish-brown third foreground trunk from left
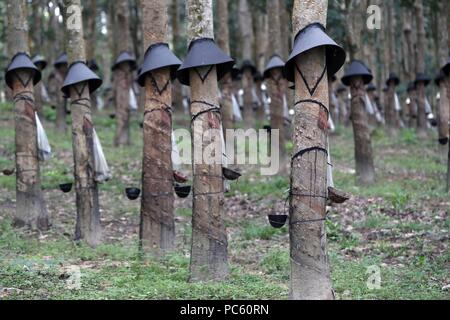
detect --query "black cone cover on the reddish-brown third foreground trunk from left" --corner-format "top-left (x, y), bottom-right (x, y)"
top-left (138, 43), bottom-right (181, 87)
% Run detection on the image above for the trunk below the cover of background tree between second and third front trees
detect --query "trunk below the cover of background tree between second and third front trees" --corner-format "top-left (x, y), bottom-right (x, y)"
top-left (114, 63), bottom-right (132, 147)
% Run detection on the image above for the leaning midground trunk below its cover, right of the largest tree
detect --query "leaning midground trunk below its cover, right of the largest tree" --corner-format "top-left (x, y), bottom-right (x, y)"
top-left (350, 77), bottom-right (375, 185)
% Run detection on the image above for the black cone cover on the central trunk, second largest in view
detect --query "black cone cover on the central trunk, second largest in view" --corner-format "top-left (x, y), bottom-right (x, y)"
top-left (177, 38), bottom-right (234, 86)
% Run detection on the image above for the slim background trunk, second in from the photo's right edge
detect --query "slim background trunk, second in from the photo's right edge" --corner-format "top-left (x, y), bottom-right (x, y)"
top-left (414, 0), bottom-right (427, 137)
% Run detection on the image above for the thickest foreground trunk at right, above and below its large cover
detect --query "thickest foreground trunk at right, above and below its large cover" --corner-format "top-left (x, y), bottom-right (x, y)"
top-left (289, 0), bottom-right (334, 300)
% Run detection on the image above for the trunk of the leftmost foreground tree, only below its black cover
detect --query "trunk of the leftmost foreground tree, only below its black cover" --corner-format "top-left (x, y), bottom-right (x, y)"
top-left (13, 71), bottom-right (50, 230)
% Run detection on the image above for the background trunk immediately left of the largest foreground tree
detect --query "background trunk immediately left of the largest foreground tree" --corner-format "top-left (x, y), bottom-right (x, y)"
top-left (266, 0), bottom-right (286, 163)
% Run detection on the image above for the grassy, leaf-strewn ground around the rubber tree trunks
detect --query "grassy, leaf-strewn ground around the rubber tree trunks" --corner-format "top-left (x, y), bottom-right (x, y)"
top-left (0, 104), bottom-right (450, 299)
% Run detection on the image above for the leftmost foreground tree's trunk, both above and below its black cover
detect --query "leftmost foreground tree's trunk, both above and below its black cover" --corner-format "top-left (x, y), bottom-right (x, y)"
top-left (6, 0), bottom-right (50, 230)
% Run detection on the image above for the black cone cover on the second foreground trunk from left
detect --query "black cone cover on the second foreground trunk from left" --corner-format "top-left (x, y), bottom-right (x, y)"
top-left (61, 61), bottom-right (103, 97)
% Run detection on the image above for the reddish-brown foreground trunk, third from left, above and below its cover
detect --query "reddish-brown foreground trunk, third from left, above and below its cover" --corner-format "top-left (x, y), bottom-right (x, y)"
top-left (140, 0), bottom-right (175, 255)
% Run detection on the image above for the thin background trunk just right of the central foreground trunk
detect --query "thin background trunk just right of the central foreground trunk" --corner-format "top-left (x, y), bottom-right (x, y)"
top-left (217, 0), bottom-right (234, 139)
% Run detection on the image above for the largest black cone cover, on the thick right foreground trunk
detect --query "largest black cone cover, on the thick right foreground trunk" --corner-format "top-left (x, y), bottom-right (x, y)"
top-left (285, 23), bottom-right (346, 82)
